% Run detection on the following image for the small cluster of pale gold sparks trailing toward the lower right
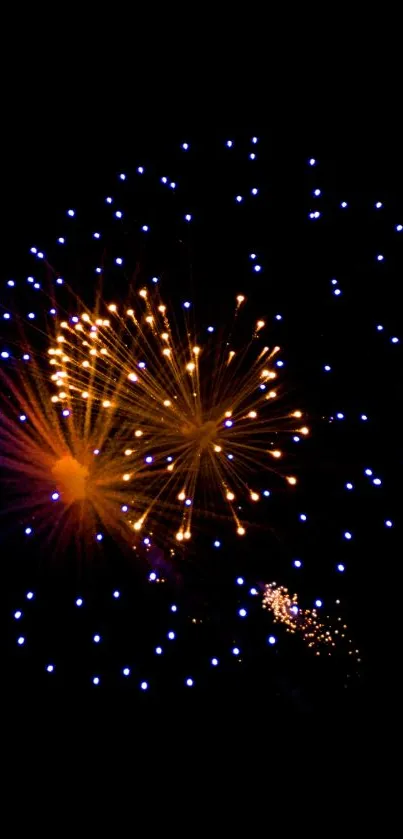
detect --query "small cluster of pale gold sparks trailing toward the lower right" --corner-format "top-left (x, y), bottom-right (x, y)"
top-left (262, 583), bottom-right (358, 655)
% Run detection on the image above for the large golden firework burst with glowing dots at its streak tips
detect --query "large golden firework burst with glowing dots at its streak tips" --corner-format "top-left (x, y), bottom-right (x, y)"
top-left (41, 288), bottom-right (309, 542)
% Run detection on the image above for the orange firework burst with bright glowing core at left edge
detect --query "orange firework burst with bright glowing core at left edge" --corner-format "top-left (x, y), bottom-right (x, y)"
top-left (0, 334), bottom-right (152, 550)
